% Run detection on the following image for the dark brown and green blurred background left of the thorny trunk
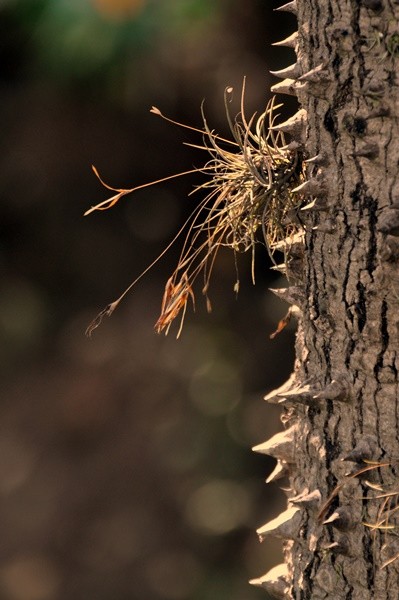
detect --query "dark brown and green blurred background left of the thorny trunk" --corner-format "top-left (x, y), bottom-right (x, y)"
top-left (0, 0), bottom-right (295, 600)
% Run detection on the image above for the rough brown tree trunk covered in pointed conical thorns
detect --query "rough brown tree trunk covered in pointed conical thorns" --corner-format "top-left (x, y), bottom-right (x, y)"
top-left (253, 0), bottom-right (399, 600)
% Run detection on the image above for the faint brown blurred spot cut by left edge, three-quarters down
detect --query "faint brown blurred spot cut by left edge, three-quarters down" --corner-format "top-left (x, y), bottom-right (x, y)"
top-left (0, 436), bottom-right (36, 494)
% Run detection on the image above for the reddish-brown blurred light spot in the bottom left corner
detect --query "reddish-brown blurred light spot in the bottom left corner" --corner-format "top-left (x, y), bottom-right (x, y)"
top-left (0, 556), bottom-right (60, 600)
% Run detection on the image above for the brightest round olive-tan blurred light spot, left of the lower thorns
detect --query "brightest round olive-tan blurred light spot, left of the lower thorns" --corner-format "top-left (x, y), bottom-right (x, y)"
top-left (186, 480), bottom-right (250, 535)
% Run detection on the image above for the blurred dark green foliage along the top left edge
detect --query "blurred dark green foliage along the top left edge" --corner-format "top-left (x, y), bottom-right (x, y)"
top-left (0, 0), bottom-right (226, 85)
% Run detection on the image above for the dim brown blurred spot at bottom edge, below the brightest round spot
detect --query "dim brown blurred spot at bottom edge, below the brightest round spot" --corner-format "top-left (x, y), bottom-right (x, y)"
top-left (146, 551), bottom-right (203, 600)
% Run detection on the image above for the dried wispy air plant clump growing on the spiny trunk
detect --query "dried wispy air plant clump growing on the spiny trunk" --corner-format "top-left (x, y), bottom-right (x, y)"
top-left (85, 80), bottom-right (302, 337)
